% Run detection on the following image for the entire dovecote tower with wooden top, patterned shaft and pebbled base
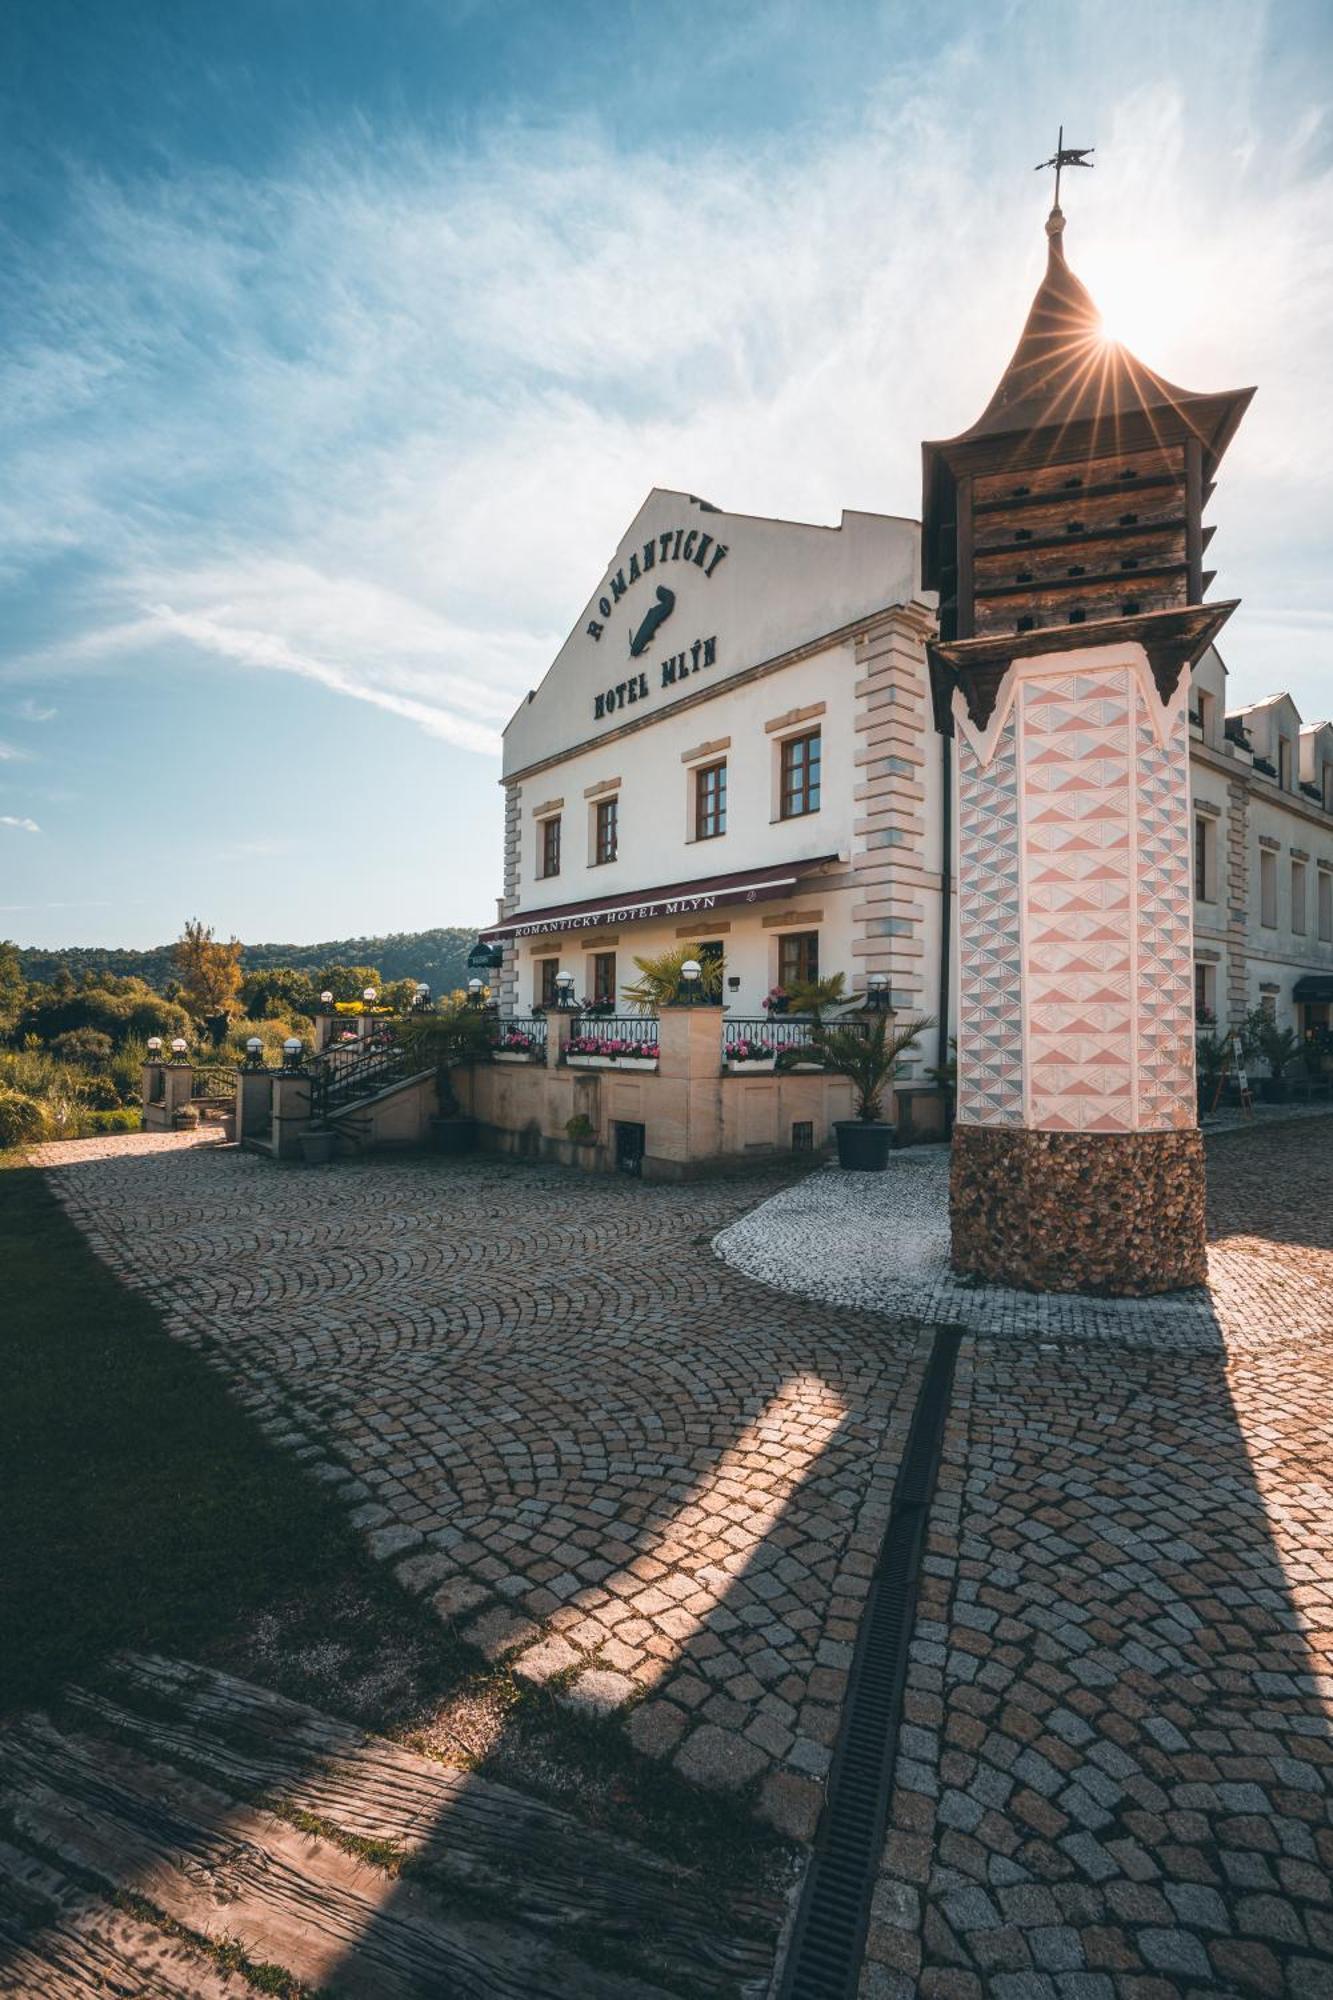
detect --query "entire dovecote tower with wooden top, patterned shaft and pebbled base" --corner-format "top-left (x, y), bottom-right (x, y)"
top-left (923, 194), bottom-right (1253, 1294)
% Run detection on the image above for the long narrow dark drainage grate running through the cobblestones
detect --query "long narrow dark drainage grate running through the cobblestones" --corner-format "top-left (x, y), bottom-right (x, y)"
top-left (779, 1326), bottom-right (963, 2000)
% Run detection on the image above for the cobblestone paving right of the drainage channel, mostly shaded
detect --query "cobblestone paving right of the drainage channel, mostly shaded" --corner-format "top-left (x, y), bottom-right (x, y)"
top-left (861, 1120), bottom-right (1333, 2000)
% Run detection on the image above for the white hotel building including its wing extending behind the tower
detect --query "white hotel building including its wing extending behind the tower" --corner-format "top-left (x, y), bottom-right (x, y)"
top-left (482, 490), bottom-right (1333, 1064)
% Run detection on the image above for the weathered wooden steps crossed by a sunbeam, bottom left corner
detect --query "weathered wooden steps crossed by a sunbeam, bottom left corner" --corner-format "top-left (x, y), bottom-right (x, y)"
top-left (0, 1656), bottom-right (779, 2000)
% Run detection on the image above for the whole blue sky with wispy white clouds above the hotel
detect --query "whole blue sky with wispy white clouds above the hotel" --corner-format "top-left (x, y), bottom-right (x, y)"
top-left (0, 0), bottom-right (1333, 944)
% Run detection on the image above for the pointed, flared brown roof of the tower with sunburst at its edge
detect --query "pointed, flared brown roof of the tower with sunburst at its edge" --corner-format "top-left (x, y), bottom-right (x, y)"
top-left (921, 208), bottom-right (1255, 584)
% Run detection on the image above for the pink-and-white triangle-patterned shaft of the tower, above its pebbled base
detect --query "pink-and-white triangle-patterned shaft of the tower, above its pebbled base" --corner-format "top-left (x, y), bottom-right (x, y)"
top-left (957, 648), bottom-right (1195, 1132)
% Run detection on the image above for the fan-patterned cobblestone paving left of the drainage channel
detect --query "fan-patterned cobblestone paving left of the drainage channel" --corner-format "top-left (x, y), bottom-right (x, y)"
top-left (31, 1138), bottom-right (927, 1836)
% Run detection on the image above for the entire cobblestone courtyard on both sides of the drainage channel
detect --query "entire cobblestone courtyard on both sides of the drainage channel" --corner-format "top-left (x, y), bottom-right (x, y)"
top-left (31, 1118), bottom-right (1333, 2000)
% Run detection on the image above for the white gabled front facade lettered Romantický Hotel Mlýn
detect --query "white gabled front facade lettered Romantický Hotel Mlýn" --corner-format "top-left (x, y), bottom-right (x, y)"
top-left (484, 490), bottom-right (941, 1040)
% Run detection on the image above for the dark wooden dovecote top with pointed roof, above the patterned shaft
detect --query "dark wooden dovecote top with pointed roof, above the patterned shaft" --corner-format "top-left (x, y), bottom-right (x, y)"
top-left (921, 206), bottom-right (1253, 724)
